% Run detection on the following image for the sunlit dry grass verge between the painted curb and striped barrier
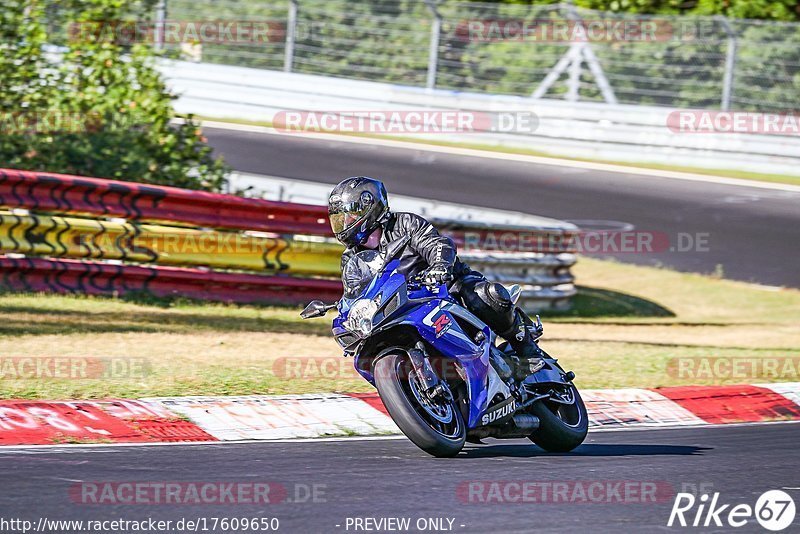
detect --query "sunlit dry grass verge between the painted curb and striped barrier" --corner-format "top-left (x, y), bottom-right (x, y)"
top-left (0, 258), bottom-right (800, 399)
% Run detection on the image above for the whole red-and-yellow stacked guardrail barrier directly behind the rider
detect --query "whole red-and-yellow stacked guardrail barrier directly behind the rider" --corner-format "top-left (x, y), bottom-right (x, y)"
top-left (0, 169), bottom-right (577, 311)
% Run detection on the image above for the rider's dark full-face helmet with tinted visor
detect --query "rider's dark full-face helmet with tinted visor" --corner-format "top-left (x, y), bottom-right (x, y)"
top-left (328, 176), bottom-right (389, 246)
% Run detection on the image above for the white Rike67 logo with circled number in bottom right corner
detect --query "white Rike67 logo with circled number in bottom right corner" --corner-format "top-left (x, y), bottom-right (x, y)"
top-left (667, 490), bottom-right (796, 532)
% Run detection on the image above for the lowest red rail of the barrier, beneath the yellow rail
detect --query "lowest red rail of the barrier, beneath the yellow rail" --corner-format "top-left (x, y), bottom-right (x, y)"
top-left (0, 256), bottom-right (342, 304)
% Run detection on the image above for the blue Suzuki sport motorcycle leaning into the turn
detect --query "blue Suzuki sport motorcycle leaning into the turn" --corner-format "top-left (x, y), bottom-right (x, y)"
top-left (300, 237), bottom-right (588, 457)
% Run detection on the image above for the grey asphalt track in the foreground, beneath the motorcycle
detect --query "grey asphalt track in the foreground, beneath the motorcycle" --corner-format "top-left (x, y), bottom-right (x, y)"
top-left (0, 423), bottom-right (800, 533)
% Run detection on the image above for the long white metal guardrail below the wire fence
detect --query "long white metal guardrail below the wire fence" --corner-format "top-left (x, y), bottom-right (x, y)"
top-left (161, 62), bottom-right (800, 175)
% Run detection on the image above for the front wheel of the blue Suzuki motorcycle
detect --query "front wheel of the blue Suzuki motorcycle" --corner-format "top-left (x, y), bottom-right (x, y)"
top-left (373, 352), bottom-right (467, 457)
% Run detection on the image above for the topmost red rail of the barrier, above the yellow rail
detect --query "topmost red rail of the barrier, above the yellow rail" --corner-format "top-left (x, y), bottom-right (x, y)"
top-left (0, 169), bottom-right (575, 253)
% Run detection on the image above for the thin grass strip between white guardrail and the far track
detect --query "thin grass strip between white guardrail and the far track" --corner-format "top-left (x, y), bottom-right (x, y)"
top-left (198, 117), bottom-right (800, 185)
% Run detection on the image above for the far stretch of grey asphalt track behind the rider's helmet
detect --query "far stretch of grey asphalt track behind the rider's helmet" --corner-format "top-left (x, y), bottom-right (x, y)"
top-left (204, 128), bottom-right (800, 287)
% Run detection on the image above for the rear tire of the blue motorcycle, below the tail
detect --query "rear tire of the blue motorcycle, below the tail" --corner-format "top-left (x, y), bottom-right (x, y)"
top-left (528, 384), bottom-right (589, 452)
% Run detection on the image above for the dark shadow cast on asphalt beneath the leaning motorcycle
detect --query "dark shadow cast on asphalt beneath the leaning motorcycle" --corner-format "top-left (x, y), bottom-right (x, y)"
top-left (457, 443), bottom-right (711, 458)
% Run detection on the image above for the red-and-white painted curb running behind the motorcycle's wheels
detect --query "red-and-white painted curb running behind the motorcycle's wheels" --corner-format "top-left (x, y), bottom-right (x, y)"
top-left (0, 382), bottom-right (800, 445)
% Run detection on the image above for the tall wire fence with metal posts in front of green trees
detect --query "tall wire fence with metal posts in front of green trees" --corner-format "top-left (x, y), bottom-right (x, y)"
top-left (83, 0), bottom-right (800, 112)
